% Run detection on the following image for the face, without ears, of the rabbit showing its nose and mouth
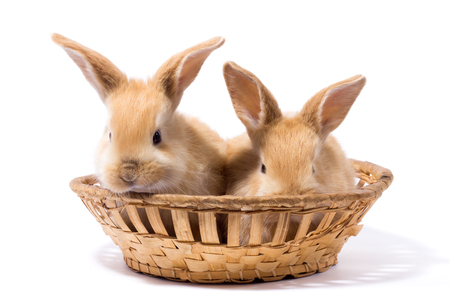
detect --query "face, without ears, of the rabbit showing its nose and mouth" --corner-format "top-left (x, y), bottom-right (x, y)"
top-left (97, 80), bottom-right (183, 192)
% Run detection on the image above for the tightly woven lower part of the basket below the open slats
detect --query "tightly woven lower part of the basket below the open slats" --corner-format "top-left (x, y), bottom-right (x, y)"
top-left (102, 218), bottom-right (362, 283)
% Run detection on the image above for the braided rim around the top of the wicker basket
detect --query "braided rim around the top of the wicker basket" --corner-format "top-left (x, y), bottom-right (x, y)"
top-left (70, 159), bottom-right (394, 212)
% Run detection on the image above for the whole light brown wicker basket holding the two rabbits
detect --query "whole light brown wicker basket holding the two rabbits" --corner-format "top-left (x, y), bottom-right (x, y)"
top-left (70, 160), bottom-right (393, 283)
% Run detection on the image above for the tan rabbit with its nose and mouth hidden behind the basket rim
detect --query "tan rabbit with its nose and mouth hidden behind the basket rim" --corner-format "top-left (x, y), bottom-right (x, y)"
top-left (223, 62), bottom-right (366, 245)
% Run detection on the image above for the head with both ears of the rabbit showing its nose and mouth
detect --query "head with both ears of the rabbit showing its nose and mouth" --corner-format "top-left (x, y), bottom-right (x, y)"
top-left (52, 34), bottom-right (224, 193)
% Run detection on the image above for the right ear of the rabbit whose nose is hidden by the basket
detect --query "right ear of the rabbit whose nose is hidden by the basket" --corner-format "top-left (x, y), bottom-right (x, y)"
top-left (300, 75), bottom-right (366, 138)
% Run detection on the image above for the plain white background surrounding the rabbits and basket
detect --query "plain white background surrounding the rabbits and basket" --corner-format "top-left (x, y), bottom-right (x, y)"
top-left (0, 0), bottom-right (450, 299)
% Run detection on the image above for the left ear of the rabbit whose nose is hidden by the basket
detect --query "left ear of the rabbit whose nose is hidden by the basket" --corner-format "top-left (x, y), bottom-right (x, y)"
top-left (223, 62), bottom-right (282, 135)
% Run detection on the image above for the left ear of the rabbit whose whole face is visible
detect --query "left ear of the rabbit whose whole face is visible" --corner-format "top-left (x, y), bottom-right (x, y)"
top-left (52, 33), bottom-right (127, 102)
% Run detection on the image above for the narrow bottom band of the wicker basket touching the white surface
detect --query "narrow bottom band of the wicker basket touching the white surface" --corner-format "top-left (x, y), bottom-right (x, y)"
top-left (124, 254), bottom-right (338, 283)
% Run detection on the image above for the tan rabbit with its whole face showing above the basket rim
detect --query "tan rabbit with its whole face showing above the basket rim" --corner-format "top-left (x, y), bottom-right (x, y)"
top-left (52, 33), bottom-right (226, 239)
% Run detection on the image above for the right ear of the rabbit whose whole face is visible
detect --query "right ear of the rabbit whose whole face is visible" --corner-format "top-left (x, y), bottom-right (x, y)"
top-left (154, 37), bottom-right (225, 109)
